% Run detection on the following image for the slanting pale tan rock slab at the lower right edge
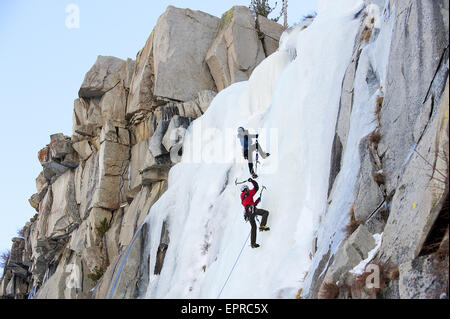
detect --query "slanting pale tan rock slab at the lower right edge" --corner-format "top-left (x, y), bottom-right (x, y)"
top-left (380, 79), bottom-right (449, 265)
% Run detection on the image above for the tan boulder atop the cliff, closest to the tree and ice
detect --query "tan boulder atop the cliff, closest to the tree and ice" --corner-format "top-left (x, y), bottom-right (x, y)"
top-left (206, 6), bottom-right (266, 91)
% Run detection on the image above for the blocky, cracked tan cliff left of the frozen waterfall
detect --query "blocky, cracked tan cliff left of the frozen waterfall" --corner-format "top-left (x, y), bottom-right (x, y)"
top-left (0, 7), bottom-right (241, 299)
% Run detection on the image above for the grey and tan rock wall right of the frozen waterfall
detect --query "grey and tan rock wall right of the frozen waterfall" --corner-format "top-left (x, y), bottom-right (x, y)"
top-left (305, 1), bottom-right (449, 299)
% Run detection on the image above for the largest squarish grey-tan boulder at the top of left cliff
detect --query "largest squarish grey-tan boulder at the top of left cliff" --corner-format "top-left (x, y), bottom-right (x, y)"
top-left (153, 6), bottom-right (220, 102)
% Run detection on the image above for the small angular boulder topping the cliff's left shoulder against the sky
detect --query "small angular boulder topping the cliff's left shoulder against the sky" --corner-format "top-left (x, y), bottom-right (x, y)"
top-left (78, 55), bottom-right (127, 98)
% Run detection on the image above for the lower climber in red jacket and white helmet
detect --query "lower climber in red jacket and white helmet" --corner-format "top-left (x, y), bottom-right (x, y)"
top-left (241, 178), bottom-right (270, 248)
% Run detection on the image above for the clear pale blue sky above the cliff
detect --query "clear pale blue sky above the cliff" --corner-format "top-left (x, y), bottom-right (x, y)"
top-left (0, 0), bottom-right (317, 274)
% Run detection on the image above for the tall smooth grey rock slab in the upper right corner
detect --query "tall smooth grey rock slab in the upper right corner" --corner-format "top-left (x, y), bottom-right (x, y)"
top-left (380, 1), bottom-right (448, 194)
